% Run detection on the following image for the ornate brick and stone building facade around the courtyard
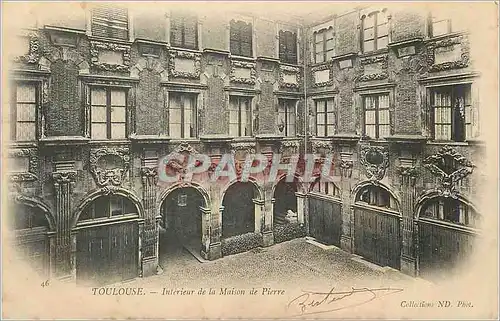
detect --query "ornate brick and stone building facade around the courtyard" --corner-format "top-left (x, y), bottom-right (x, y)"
top-left (4, 1), bottom-right (483, 283)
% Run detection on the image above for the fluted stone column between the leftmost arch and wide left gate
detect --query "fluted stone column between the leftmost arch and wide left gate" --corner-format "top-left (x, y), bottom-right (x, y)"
top-left (52, 171), bottom-right (76, 279)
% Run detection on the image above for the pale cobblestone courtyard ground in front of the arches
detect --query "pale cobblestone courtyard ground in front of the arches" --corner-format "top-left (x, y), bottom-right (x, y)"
top-left (127, 229), bottom-right (422, 288)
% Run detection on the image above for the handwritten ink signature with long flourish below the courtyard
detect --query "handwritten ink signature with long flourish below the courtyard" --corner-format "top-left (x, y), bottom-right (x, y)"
top-left (287, 287), bottom-right (403, 315)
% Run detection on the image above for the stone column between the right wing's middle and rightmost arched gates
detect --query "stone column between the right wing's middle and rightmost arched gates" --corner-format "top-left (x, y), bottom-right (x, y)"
top-left (399, 167), bottom-right (416, 276)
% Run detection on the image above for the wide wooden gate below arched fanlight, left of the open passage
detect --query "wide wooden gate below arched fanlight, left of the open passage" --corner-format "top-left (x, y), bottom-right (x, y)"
top-left (76, 221), bottom-right (138, 285)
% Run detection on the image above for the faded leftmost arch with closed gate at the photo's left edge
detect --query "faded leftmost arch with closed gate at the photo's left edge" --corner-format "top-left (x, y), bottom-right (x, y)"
top-left (9, 203), bottom-right (50, 278)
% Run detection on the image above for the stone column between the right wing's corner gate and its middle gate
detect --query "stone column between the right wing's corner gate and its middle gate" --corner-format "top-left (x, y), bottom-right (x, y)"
top-left (340, 156), bottom-right (354, 252)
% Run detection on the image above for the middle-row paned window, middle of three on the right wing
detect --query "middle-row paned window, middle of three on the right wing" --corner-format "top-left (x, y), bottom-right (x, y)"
top-left (363, 94), bottom-right (391, 138)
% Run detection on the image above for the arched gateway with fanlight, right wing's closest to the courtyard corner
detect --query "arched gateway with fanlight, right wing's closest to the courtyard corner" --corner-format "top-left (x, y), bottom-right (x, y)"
top-left (308, 177), bottom-right (342, 247)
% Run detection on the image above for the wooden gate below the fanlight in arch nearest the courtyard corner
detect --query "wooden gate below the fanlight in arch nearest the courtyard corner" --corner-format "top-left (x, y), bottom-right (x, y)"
top-left (309, 196), bottom-right (342, 247)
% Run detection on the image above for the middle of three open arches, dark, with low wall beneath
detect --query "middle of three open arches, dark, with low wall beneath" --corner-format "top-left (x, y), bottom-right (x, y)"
top-left (222, 182), bottom-right (258, 238)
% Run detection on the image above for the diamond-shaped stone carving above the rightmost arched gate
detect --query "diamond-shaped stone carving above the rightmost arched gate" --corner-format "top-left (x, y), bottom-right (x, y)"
top-left (423, 145), bottom-right (475, 198)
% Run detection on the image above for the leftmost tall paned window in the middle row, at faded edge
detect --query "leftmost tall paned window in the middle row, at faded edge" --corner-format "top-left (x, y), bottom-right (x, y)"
top-left (9, 82), bottom-right (38, 141)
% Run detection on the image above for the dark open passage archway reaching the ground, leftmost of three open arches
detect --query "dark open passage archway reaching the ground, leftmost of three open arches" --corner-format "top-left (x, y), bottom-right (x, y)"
top-left (159, 187), bottom-right (206, 267)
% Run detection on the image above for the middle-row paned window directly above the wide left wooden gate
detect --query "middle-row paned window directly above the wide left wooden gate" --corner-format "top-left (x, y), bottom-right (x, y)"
top-left (90, 87), bottom-right (127, 139)
